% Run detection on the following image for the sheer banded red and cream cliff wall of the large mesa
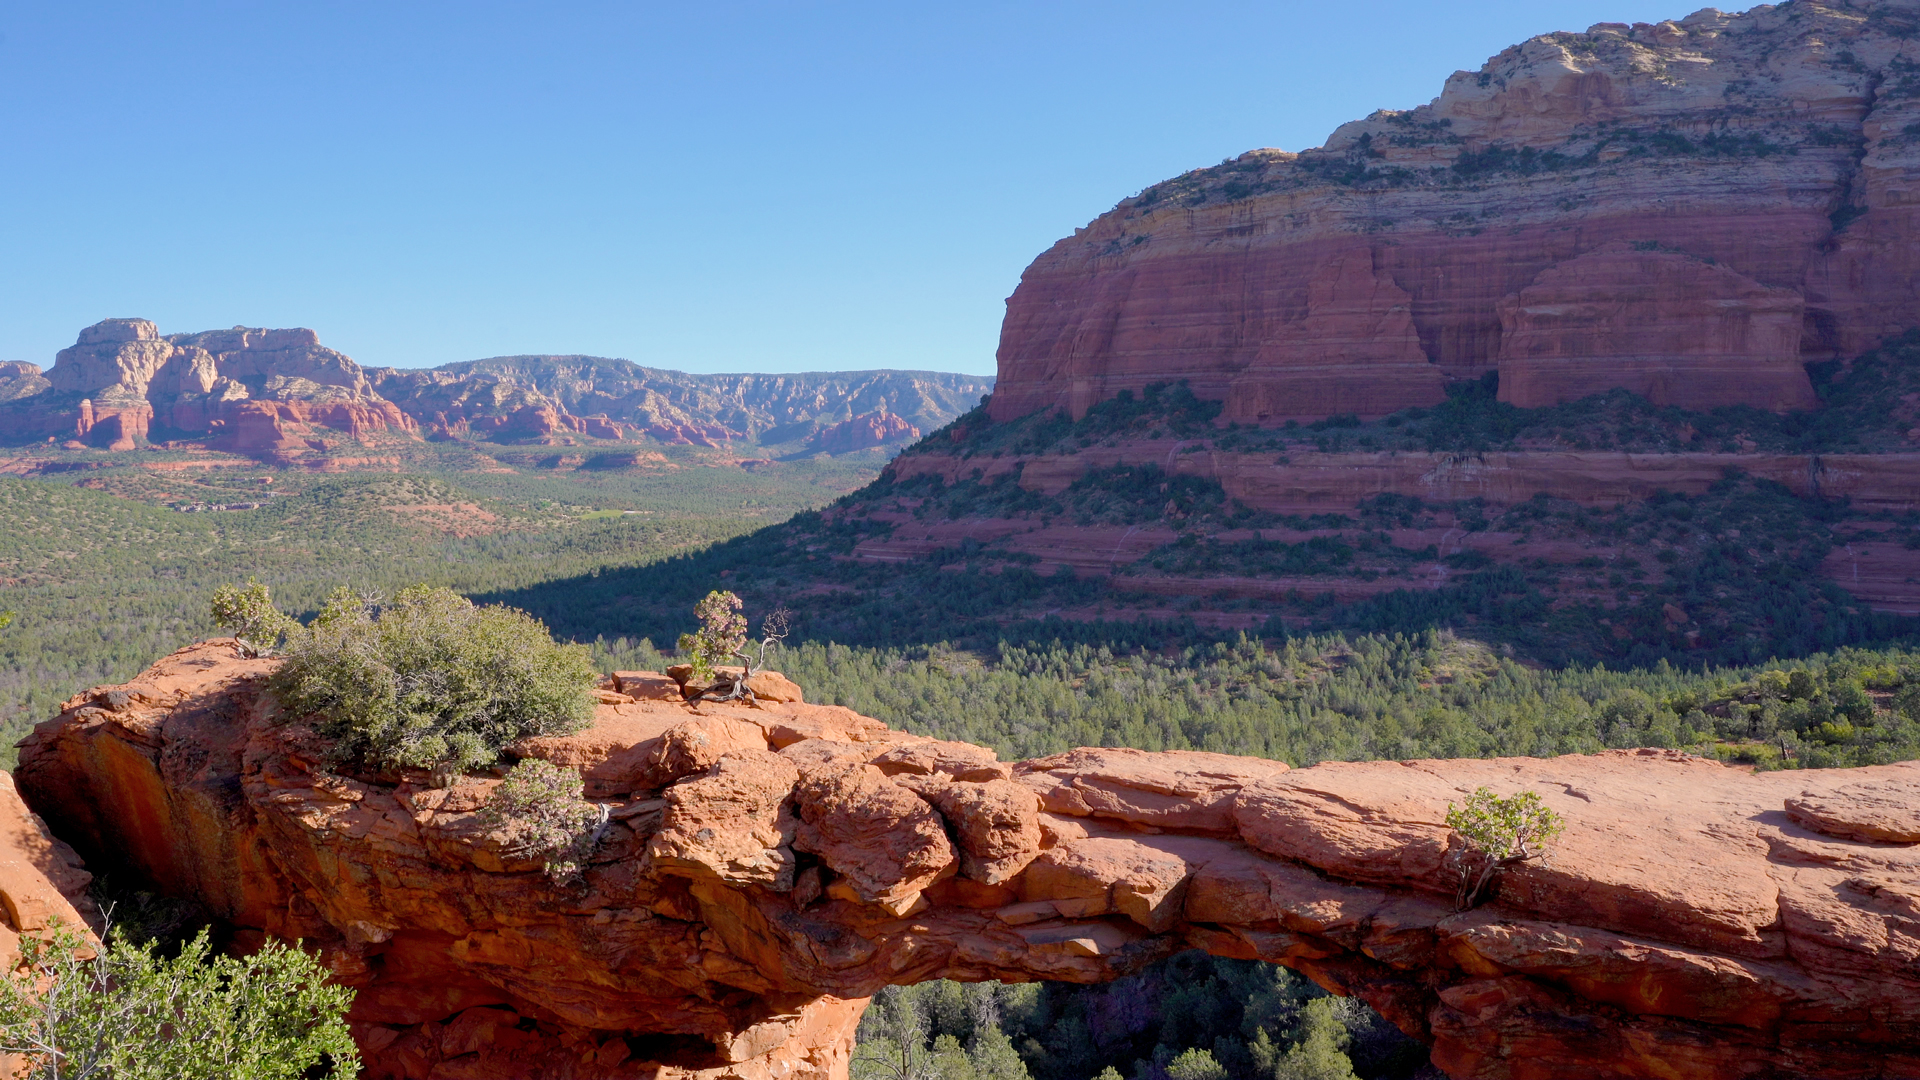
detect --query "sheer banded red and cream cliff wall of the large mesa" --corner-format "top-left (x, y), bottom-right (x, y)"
top-left (991, 0), bottom-right (1920, 423)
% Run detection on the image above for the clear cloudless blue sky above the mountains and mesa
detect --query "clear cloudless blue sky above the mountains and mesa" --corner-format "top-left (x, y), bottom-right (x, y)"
top-left (0, 0), bottom-right (1690, 373)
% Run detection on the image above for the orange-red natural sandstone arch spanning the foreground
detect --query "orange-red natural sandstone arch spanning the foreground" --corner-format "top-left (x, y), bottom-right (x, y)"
top-left (19, 642), bottom-right (1920, 1080)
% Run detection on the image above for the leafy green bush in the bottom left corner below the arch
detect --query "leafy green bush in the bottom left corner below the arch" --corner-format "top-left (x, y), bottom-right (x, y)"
top-left (0, 930), bottom-right (359, 1080)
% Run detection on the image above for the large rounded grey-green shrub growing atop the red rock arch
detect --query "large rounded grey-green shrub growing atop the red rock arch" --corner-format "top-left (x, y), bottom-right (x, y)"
top-left (271, 586), bottom-right (597, 771)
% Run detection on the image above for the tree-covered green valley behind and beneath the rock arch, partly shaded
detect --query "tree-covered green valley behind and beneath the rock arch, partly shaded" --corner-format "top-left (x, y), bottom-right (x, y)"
top-left (0, 388), bottom-right (1920, 1080)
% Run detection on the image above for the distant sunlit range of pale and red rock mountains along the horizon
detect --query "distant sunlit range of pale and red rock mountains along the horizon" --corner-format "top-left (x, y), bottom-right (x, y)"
top-left (0, 319), bottom-right (993, 459)
